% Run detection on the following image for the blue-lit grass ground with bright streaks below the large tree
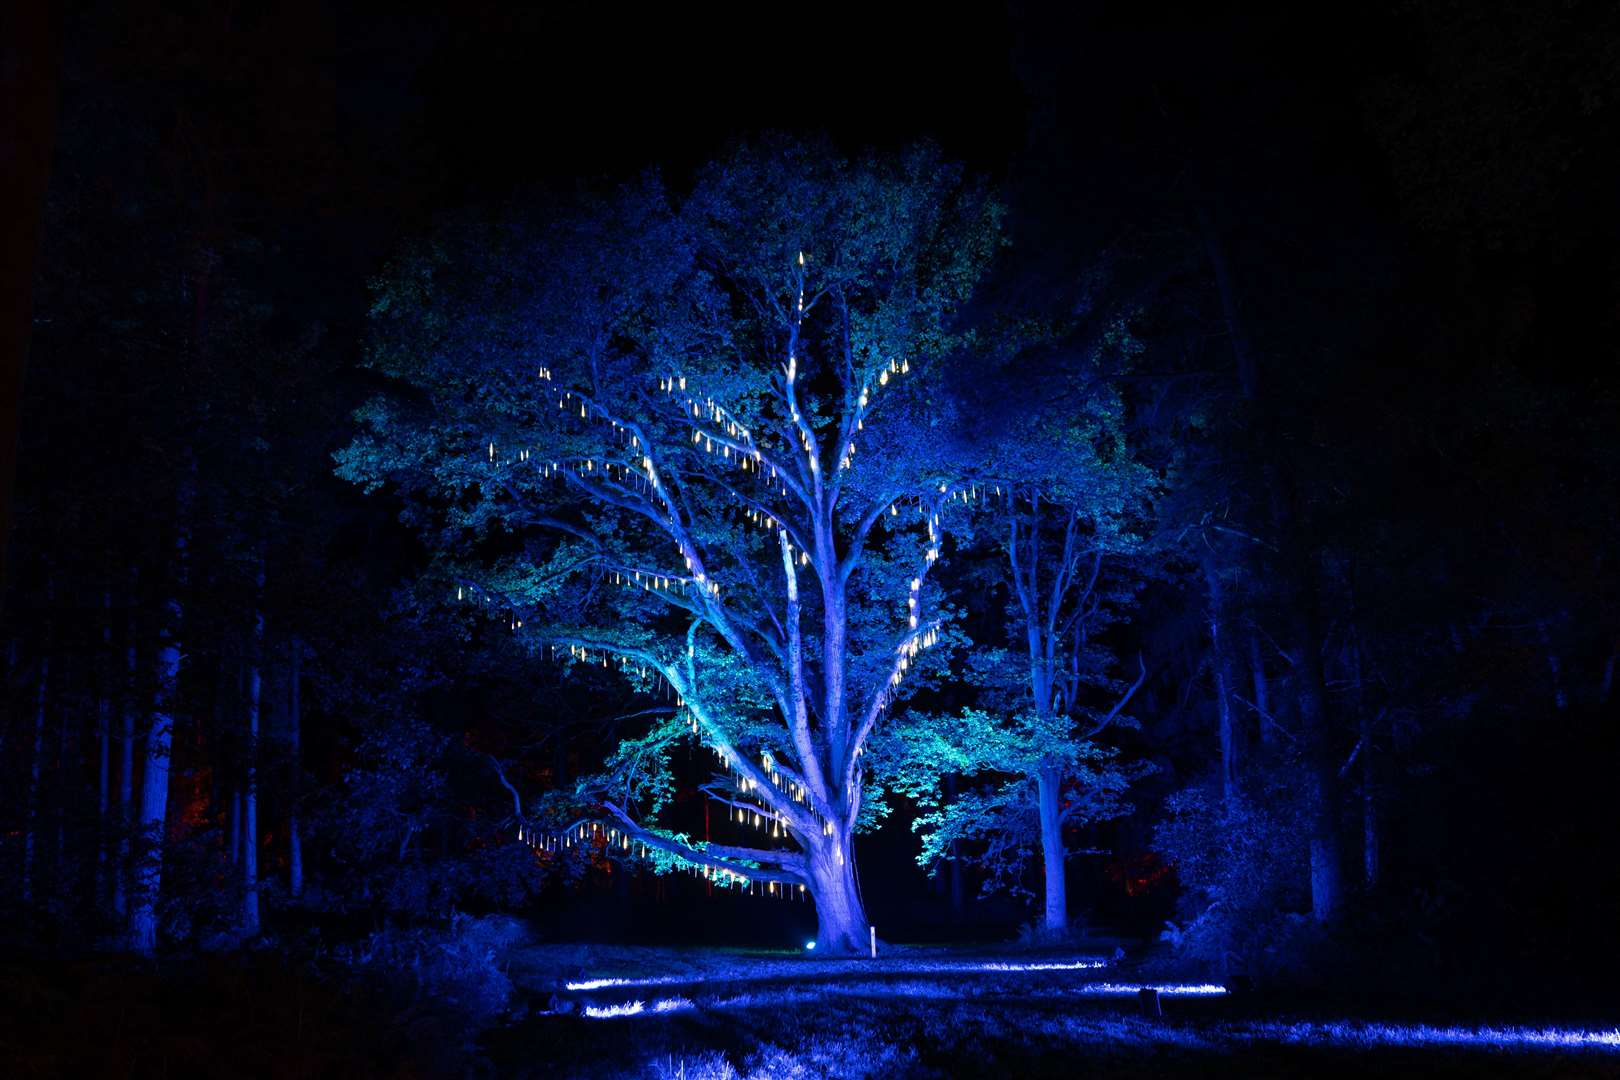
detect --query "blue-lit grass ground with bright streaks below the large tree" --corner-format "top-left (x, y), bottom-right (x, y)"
top-left (484, 946), bottom-right (1620, 1080)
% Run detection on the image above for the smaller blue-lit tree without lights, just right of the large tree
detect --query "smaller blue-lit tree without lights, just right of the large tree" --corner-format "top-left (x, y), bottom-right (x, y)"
top-left (878, 321), bottom-right (1163, 936)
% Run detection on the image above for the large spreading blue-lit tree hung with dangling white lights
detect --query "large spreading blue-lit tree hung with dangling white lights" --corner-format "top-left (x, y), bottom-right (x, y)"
top-left (339, 142), bottom-right (1000, 952)
